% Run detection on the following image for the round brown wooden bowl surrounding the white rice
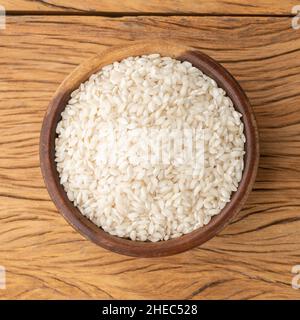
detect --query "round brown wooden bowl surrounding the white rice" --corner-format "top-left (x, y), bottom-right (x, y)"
top-left (40, 41), bottom-right (259, 257)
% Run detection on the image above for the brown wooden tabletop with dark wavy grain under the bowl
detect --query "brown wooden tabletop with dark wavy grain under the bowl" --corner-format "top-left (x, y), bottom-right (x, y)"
top-left (0, 0), bottom-right (300, 299)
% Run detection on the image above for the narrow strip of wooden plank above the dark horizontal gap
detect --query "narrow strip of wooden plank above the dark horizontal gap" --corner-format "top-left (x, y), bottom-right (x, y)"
top-left (1, 0), bottom-right (299, 15)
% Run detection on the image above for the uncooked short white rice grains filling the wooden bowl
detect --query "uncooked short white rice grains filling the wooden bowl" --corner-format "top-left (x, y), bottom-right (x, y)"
top-left (55, 54), bottom-right (245, 242)
